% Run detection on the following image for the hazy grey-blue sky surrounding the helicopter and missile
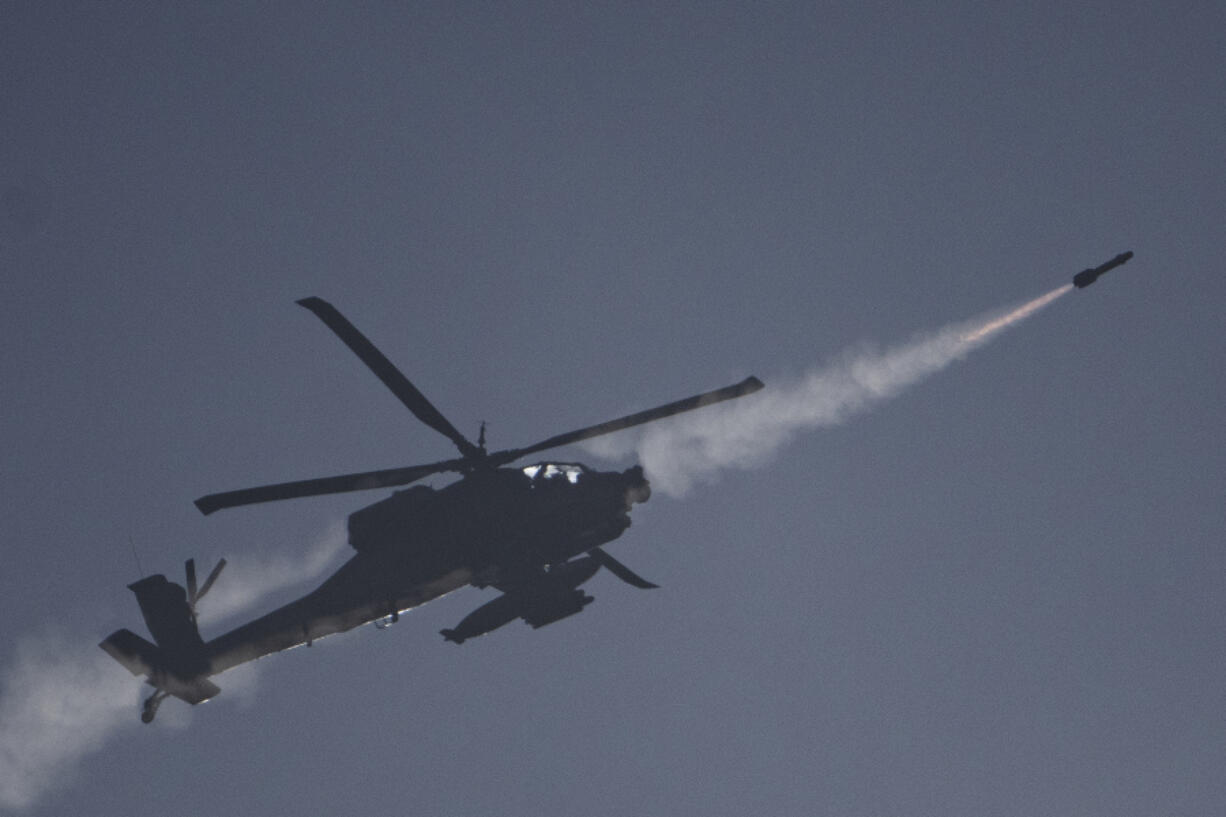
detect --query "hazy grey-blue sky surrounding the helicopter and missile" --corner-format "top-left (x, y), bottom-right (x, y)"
top-left (0, 1), bottom-right (1226, 817)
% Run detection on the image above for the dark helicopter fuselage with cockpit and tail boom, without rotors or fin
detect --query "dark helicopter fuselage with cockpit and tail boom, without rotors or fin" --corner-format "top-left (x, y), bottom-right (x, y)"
top-left (198, 464), bottom-right (651, 675)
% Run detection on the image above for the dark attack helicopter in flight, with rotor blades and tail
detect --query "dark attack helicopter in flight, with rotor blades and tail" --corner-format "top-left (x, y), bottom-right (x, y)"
top-left (99, 297), bottom-right (763, 724)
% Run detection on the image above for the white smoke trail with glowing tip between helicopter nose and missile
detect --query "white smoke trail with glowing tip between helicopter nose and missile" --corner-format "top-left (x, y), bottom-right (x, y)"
top-left (617, 283), bottom-right (1073, 496)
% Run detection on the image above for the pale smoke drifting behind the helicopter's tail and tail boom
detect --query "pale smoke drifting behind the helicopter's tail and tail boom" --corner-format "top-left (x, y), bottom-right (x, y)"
top-left (0, 523), bottom-right (346, 811)
